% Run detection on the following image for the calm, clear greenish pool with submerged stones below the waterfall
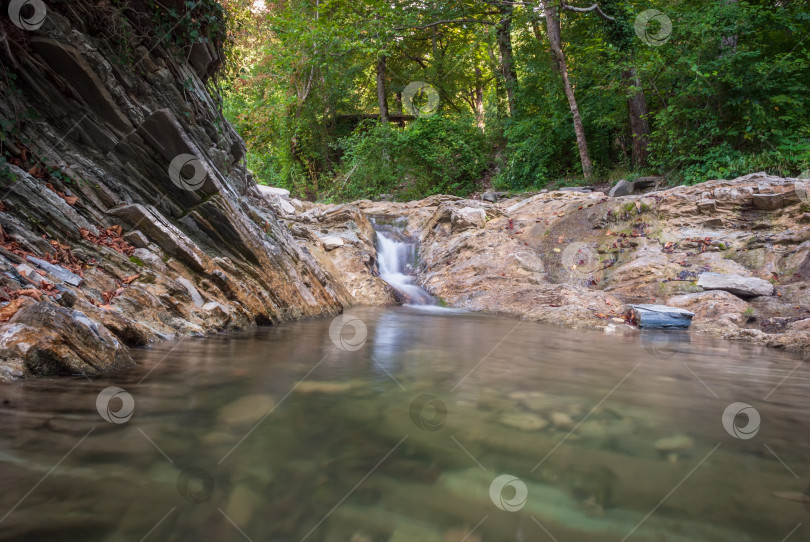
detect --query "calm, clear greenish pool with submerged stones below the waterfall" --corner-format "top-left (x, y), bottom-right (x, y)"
top-left (0, 308), bottom-right (810, 542)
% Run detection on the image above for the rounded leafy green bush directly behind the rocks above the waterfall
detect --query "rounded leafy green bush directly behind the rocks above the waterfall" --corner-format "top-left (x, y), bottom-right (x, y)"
top-left (336, 115), bottom-right (486, 200)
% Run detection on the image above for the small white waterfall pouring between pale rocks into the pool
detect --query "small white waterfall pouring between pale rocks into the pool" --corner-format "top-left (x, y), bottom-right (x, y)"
top-left (374, 224), bottom-right (436, 305)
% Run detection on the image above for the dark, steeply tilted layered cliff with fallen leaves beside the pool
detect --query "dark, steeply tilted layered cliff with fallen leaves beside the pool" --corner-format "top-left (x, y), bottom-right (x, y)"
top-left (0, 0), bottom-right (350, 380)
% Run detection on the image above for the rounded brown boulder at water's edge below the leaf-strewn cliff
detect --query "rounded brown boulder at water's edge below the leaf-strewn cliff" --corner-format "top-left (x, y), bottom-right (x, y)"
top-left (0, 302), bottom-right (134, 379)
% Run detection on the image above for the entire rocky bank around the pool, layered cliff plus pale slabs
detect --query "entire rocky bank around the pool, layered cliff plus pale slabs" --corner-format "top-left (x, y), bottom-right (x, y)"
top-left (0, 5), bottom-right (810, 381)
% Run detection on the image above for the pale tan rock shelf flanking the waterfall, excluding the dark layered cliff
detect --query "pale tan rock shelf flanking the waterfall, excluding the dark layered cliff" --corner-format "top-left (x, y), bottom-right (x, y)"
top-left (284, 173), bottom-right (810, 350)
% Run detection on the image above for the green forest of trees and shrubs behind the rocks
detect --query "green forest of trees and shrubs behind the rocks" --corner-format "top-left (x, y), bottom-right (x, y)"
top-left (219, 0), bottom-right (810, 200)
